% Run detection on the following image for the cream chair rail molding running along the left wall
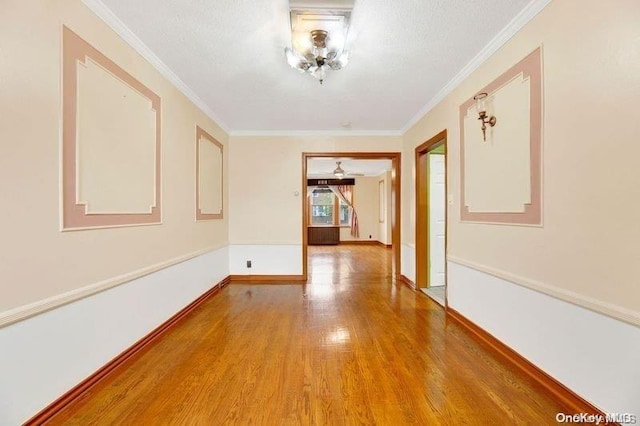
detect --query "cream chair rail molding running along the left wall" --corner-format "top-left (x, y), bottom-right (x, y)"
top-left (0, 247), bottom-right (228, 328)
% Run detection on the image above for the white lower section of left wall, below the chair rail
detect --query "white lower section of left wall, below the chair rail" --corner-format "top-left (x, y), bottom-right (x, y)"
top-left (0, 247), bottom-right (229, 425)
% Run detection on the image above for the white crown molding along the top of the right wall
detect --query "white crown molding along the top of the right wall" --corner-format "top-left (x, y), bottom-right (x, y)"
top-left (400, 0), bottom-right (551, 134)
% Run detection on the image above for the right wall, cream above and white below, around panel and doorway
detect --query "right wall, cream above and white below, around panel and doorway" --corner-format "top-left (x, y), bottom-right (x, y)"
top-left (402, 0), bottom-right (640, 414)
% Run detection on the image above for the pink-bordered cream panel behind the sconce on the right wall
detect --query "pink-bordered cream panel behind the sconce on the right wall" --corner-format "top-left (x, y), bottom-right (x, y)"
top-left (459, 48), bottom-right (542, 225)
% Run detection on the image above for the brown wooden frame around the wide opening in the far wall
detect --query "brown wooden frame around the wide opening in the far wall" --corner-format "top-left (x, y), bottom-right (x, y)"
top-left (302, 152), bottom-right (401, 280)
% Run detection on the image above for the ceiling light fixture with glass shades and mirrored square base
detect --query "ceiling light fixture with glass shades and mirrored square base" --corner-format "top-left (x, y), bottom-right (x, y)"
top-left (285, 0), bottom-right (353, 84)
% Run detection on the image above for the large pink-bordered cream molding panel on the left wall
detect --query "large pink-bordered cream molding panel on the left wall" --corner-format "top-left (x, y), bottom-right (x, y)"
top-left (62, 26), bottom-right (161, 230)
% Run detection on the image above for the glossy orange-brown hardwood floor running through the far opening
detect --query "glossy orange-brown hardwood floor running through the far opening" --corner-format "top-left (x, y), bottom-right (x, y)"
top-left (49, 246), bottom-right (568, 425)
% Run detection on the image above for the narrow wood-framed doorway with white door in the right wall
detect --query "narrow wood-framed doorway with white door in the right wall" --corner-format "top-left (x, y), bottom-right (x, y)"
top-left (415, 130), bottom-right (447, 306)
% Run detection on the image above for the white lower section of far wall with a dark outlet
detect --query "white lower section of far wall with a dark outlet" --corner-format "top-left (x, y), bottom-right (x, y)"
top-left (229, 244), bottom-right (302, 275)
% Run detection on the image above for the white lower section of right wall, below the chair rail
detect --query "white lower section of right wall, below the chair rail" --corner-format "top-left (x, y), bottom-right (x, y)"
top-left (448, 261), bottom-right (640, 415)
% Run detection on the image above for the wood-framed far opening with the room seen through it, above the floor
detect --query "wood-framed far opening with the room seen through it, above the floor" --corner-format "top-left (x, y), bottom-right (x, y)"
top-left (302, 152), bottom-right (400, 277)
